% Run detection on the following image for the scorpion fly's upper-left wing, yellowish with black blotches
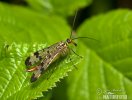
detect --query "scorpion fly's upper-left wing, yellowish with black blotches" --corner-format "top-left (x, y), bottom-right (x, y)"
top-left (25, 42), bottom-right (61, 66)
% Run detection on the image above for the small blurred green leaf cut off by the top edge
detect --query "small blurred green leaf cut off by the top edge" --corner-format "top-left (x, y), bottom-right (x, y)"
top-left (27, 0), bottom-right (92, 16)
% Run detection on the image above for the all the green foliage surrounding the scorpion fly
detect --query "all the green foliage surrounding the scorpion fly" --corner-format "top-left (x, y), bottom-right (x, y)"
top-left (0, 0), bottom-right (132, 100)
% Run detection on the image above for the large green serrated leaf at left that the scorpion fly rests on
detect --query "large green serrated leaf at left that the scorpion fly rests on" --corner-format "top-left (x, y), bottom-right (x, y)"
top-left (0, 3), bottom-right (79, 100)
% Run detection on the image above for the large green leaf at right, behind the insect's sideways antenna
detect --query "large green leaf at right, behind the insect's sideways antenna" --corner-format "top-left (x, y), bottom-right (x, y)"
top-left (64, 9), bottom-right (132, 100)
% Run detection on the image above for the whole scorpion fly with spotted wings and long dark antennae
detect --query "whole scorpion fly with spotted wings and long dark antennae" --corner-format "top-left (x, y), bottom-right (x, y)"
top-left (25, 11), bottom-right (96, 82)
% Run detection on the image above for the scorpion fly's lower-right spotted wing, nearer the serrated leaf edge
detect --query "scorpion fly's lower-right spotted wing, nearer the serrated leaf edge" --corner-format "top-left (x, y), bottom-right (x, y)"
top-left (30, 42), bottom-right (68, 82)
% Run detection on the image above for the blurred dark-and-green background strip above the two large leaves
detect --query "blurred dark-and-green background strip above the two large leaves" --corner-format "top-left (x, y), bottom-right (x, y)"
top-left (1, 0), bottom-right (132, 28)
